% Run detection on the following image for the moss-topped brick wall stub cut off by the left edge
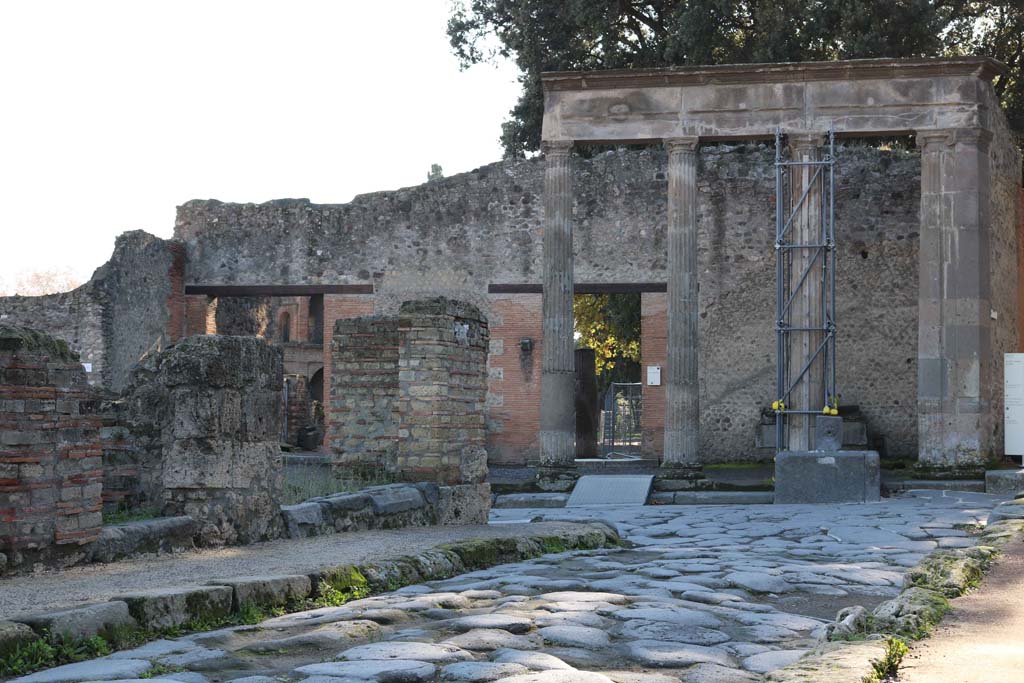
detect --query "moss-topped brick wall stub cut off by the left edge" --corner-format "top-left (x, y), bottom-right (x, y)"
top-left (0, 325), bottom-right (102, 569)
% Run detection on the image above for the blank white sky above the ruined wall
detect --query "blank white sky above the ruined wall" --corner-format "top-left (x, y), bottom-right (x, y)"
top-left (0, 0), bottom-right (519, 289)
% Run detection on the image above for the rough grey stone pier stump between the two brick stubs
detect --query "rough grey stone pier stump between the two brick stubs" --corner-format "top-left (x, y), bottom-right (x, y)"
top-left (126, 336), bottom-right (283, 545)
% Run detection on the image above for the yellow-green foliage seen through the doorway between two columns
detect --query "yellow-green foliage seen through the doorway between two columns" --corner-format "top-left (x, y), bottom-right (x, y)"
top-left (572, 294), bottom-right (640, 391)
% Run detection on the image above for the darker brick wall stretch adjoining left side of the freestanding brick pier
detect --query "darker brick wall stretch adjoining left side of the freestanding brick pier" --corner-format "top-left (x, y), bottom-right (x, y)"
top-left (324, 316), bottom-right (398, 471)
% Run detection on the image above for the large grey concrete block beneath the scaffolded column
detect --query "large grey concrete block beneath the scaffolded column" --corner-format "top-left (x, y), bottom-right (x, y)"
top-left (775, 451), bottom-right (881, 504)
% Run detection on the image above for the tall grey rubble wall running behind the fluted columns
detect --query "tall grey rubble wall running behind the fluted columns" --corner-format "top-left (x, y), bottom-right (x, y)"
top-left (176, 144), bottom-right (921, 462)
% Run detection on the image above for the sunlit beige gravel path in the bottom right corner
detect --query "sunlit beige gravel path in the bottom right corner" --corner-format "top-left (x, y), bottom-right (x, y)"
top-left (899, 541), bottom-right (1024, 683)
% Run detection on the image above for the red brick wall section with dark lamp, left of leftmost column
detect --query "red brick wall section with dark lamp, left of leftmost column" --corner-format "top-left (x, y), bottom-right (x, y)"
top-left (486, 294), bottom-right (543, 465)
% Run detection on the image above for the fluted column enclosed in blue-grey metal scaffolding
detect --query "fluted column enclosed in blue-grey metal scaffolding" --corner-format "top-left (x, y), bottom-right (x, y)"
top-left (784, 133), bottom-right (825, 452)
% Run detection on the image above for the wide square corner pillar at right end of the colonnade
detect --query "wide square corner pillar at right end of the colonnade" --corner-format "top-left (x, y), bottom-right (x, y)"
top-left (918, 128), bottom-right (993, 468)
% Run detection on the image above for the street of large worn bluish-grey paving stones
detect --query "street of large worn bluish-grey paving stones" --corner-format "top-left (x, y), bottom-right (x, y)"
top-left (12, 492), bottom-right (998, 683)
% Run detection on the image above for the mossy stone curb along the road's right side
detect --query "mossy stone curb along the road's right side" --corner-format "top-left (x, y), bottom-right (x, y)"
top-left (765, 519), bottom-right (1024, 683)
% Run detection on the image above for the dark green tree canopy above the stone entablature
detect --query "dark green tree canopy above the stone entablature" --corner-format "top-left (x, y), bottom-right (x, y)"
top-left (447, 0), bottom-right (1024, 157)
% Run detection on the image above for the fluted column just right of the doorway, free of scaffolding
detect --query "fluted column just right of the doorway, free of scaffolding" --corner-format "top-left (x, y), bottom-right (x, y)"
top-left (662, 137), bottom-right (700, 479)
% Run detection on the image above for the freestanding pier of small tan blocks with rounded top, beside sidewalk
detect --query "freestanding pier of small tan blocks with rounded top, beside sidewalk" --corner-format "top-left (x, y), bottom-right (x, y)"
top-left (395, 298), bottom-right (490, 483)
